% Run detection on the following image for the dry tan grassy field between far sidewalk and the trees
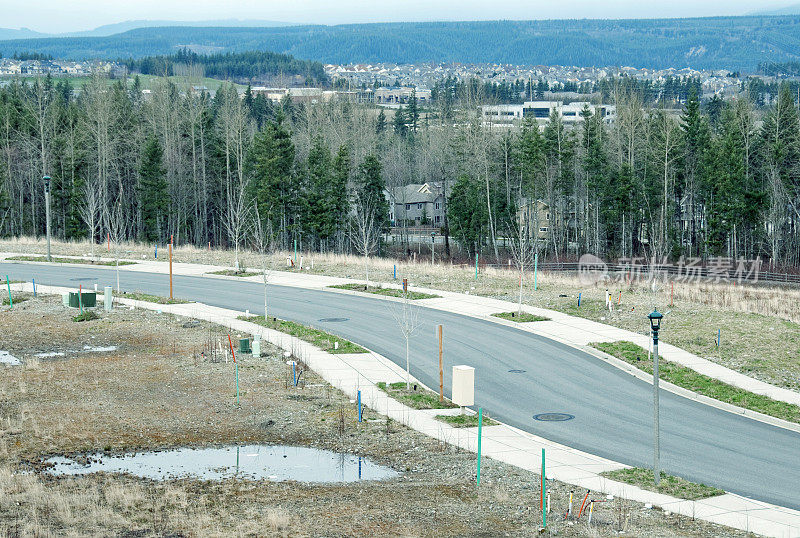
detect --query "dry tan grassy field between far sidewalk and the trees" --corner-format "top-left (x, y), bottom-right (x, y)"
top-left (6, 234), bottom-right (800, 390)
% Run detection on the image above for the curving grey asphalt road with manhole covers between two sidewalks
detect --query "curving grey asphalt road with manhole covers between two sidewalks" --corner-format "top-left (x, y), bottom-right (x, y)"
top-left (0, 263), bottom-right (800, 509)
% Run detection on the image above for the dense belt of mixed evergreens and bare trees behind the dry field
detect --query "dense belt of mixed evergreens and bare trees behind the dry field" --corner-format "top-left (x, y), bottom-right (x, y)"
top-left (0, 74), bottom-right (800, 266)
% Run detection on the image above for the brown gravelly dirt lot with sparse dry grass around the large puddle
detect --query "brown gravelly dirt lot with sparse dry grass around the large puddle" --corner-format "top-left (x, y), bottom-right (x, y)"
top-left (0, 297), bottom-right (744, 536)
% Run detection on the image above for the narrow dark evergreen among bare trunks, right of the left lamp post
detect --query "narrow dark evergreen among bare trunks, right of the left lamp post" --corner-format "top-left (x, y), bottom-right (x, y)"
top-left (139, 135), bottom-right (169, 241)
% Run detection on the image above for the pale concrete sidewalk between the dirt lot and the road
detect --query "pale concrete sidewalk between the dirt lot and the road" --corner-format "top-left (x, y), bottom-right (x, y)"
top-left (13, 283), bottom-right (800, 537)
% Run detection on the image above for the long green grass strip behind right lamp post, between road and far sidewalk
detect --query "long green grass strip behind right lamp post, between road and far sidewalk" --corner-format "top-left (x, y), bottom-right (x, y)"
top-left (591, 341), bottom-right (800, 424)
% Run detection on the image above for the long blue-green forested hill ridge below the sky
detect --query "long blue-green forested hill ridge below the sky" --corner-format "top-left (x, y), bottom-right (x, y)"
top-left (0, 16), bottom-right (800, 71)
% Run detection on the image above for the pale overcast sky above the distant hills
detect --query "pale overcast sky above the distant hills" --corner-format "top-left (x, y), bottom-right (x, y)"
top-left (0, 0), bottom-right (798, 33)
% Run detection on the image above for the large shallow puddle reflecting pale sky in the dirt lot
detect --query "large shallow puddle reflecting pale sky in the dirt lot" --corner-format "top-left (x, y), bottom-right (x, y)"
top-left (45, 445), bottom-right (399, 483)
